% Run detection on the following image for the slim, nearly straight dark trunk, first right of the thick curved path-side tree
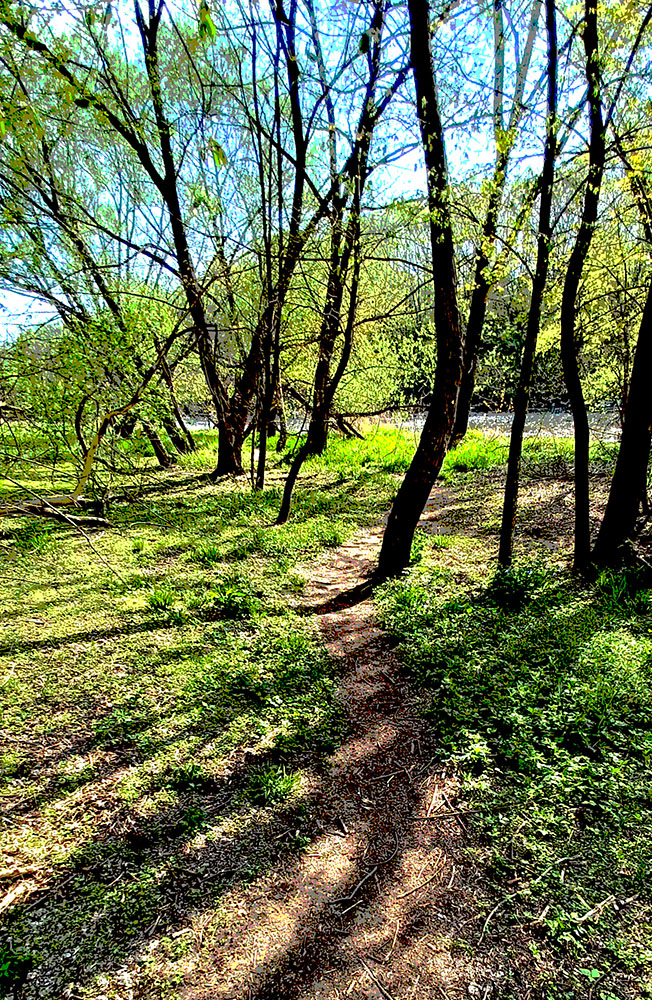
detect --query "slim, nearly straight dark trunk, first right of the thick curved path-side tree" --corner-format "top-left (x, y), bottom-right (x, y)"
top-left (498, 0), bottom-right (557, 567)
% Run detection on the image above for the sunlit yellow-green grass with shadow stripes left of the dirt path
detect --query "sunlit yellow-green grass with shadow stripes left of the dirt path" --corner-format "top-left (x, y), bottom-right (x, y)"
top-left (0, 428), bottom-right (402, 1000)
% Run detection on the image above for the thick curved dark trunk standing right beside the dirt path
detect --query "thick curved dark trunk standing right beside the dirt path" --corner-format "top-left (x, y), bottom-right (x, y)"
top-left (377, 0), bottom-right (463, 578)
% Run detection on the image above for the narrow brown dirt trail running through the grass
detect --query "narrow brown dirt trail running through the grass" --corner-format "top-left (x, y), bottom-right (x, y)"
top-left (183, 498), bottom-right (502, 1000)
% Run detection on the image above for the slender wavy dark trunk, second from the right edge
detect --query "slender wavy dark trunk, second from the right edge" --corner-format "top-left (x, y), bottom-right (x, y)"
top-left (561, 0), bottom-right (605, 572)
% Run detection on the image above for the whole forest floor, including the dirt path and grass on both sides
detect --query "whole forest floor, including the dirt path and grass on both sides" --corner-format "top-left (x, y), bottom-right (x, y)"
top-left (0, 435), bottom-right (652, 1000)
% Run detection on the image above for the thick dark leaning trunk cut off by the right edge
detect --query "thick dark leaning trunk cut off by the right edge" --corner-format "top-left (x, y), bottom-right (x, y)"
top-left (593, 270), bottom-right (652, 566)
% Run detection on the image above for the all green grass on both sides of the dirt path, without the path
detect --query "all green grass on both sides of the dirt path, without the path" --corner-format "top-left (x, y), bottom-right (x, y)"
top-left (0, 422), bottom-right (640, 1000)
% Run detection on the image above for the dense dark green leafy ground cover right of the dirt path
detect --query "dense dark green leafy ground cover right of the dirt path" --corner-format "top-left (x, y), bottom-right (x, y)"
top-left (377, 564), bottom-right (652, 1000)
